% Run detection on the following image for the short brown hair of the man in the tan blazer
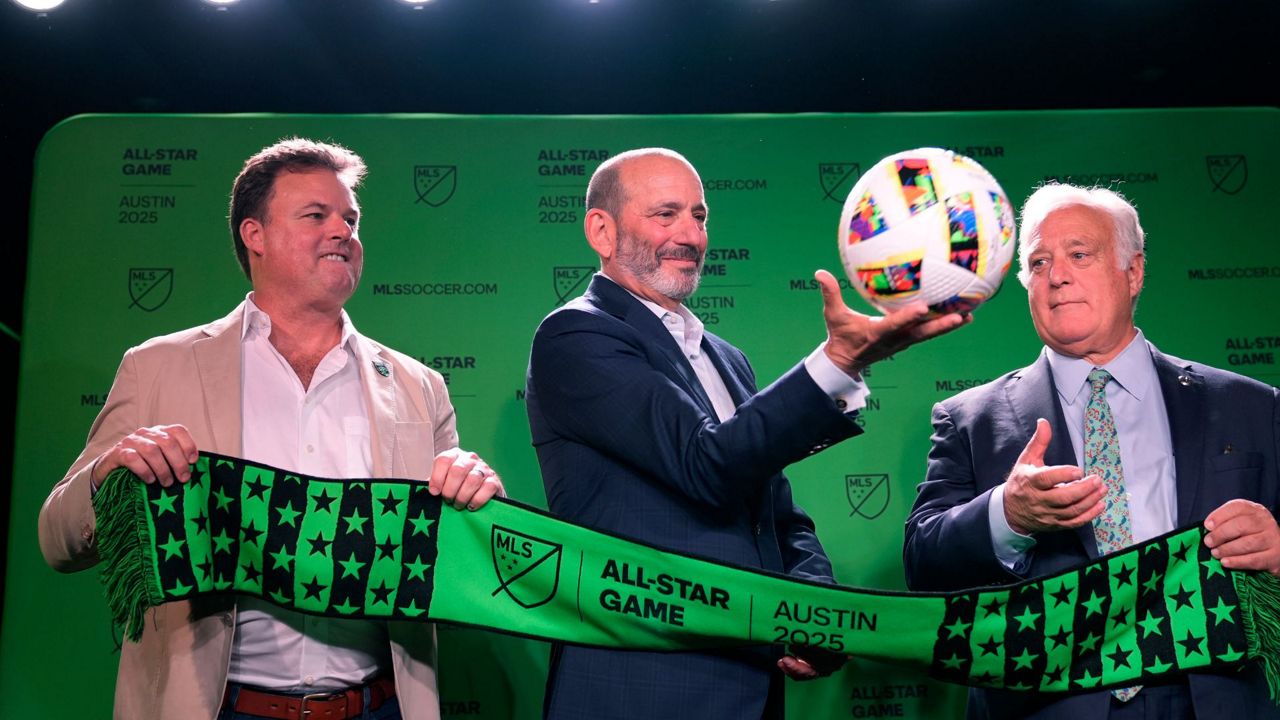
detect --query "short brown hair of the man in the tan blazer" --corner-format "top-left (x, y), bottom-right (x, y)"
top-left (229, 137), bottom-right (367, 281)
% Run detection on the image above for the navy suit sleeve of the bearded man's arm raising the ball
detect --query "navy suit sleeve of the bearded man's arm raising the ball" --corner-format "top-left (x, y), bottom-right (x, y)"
top-left (529, 311), bottom-right (858, 509)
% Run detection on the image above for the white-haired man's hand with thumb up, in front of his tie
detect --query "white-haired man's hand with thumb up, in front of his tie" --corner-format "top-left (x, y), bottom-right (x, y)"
top-left (1005, 418), bottom-right (1106, 536)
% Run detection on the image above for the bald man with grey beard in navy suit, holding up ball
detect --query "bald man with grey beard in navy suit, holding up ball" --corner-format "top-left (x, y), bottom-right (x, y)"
top-left (526, 149), bottom-right (965, 720)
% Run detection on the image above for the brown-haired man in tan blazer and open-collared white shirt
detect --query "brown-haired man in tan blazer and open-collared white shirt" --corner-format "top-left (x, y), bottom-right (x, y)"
top-left (40, 140), bottom-right (502, 720)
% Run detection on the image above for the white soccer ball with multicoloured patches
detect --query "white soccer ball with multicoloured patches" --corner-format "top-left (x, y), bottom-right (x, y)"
top-left (840, 147), bottom-right (1016, 315)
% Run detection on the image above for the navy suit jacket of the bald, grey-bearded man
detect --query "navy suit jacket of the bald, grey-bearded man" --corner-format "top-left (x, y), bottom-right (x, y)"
top-left (525, 274), bottom-right (859, 720)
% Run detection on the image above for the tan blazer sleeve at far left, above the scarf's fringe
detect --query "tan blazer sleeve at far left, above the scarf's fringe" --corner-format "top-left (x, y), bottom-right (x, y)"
top-left (38, 350), bottom-right (141, 573)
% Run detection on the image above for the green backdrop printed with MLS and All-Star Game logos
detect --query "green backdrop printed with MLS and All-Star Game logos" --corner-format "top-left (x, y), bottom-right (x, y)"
top-left (0, 109), bottom-right (1280, 719)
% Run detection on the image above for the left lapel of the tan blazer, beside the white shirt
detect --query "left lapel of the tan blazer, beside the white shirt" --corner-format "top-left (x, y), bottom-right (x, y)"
top-left (191, 302), bottom-right (244, 455)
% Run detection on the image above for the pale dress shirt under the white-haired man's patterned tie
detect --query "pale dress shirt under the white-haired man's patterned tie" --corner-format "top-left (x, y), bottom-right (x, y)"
top-left (987, 331), bottom-right (1178, 573)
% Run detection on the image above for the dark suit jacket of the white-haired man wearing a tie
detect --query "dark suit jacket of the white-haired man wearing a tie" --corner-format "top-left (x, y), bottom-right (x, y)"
top-left (904, 347), bottom-right (1280, 720)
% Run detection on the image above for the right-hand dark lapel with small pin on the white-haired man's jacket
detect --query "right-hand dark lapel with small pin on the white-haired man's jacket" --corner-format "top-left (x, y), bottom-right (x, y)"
top-left (1148, 343), bottom-right (1204, 520)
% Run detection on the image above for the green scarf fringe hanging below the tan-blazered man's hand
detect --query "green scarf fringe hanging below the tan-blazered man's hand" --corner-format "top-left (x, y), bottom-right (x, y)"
top-left (93, 468), bottom-right (163, 642)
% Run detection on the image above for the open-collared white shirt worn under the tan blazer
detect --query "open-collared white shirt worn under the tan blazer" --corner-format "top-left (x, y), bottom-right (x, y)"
top-left (228, 293), bottom-right (390, 692)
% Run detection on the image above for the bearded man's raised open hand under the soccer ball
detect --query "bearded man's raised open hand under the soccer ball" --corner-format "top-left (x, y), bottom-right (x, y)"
top-left (813, 270), bottom-right (973, 377)
